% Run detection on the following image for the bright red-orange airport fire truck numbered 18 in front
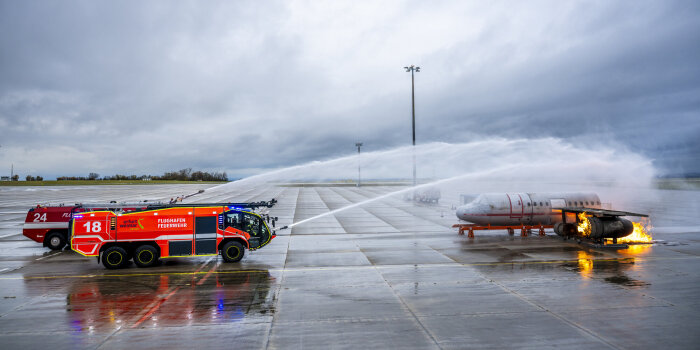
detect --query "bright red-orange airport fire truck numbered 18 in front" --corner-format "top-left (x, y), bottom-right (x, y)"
top-left (71, 200), bottom-right (275, 269)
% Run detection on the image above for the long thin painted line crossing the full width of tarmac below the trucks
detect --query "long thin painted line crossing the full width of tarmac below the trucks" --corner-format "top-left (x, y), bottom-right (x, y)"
top-left (0, 254), bottom-right (700, 280)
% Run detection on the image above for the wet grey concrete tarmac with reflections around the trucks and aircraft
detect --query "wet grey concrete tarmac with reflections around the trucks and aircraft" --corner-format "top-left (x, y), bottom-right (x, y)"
top-left (0, 185), bottom-right (700, 349)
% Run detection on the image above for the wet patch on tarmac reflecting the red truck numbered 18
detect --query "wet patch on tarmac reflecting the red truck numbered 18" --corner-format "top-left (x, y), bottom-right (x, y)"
top-left (32, 270), bottom-right (275, 332)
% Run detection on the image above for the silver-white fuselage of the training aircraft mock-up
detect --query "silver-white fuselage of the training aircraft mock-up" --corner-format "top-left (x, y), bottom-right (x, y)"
top-left (457, 192), bottom-right (601, 226)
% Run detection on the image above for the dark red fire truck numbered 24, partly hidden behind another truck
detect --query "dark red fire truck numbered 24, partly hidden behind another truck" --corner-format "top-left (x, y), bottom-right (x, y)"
top-left (22, 203), bottom-right (150, 250)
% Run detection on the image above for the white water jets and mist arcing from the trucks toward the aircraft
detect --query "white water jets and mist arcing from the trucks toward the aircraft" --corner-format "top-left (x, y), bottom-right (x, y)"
top-left (201, 138), bottom-right (655, 226)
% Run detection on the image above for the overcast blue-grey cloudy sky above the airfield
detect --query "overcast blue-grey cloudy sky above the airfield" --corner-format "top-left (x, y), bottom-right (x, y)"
top-left (0, 0), bottom-right (700, 178)
